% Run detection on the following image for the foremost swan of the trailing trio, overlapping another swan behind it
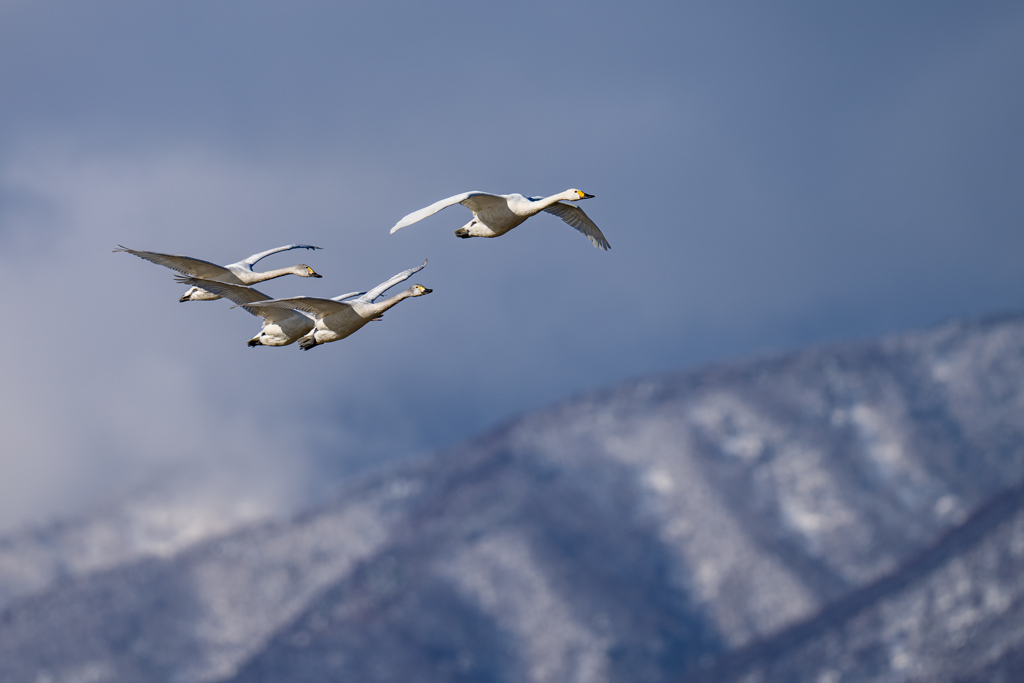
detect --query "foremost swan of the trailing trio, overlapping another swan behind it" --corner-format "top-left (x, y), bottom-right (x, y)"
top-left (240, 260), bottom-right (433, 351)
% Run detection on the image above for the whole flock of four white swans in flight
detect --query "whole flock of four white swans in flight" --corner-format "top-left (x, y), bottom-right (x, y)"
top-left (114, 189), bottom-right (610, 351)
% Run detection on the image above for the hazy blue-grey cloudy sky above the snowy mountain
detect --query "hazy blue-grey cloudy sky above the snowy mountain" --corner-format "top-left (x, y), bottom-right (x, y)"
top-left (0, 0), bottom-right (1024, 530)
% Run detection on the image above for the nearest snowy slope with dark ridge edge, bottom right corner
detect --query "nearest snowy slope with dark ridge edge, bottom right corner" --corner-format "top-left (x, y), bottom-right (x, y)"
top-left (685, 475), bottom-right (1024, 683)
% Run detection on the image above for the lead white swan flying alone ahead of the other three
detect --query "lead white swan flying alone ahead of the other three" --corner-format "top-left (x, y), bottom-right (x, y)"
top-left (391, 189), bottom-right (610, 250)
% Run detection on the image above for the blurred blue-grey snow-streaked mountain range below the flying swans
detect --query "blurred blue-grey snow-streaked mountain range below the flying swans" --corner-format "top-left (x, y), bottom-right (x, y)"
top-left (0, 315), bottom-right (1024, 683)
